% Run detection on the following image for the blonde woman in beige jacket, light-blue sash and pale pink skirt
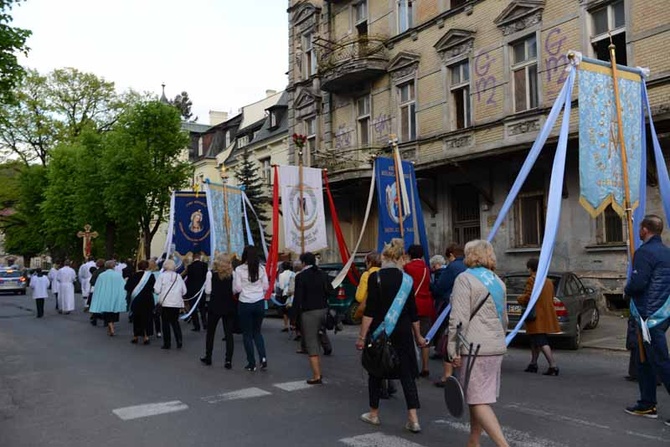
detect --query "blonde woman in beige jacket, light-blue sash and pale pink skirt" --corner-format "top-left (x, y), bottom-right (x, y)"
top-left (447, 240), bottom-right (509, 447)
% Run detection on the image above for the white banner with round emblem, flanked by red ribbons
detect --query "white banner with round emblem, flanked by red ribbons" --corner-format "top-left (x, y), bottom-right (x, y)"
top-left (279, 166), bottom-right (328, 253)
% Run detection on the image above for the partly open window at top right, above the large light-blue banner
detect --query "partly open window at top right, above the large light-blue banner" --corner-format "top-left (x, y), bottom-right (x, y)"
top-left (591, 0), bottom-right (628, 65)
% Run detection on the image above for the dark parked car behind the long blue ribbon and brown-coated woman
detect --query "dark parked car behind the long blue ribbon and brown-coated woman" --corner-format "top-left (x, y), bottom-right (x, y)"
top-left (502, 272), bottom-right (600, 349)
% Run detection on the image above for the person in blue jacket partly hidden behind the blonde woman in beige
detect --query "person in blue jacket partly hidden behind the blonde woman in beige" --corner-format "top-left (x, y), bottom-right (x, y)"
top-left (434, 244), bottom-right (467, 388)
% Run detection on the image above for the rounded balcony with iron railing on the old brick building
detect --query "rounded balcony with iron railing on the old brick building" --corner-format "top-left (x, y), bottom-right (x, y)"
top-left (319, 35), bottom-right (389, 93)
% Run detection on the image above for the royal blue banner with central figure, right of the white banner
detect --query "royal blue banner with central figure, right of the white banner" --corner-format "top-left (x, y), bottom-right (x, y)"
top-left (375, 157), bottom-right (430, 262)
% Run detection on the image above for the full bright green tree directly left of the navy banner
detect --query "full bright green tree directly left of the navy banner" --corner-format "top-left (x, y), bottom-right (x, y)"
top-left (102, 101), bottom-right (191, 255)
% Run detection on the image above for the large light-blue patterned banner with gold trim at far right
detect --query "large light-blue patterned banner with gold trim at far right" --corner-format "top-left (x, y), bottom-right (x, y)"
top-left (579, 58), bottom-right (646, 218)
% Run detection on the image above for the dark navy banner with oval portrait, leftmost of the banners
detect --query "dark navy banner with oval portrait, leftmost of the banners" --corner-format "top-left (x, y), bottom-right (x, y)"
top-left (172, 191), bottom-right (211, 258)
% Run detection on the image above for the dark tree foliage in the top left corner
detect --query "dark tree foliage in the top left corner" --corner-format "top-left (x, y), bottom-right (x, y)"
top-left (0, 0), bottom-right (32, 103)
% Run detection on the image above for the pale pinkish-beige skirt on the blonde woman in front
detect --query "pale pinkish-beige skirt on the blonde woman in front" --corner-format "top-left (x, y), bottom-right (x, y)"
top-left (459, 355), bottom-right (503, 405)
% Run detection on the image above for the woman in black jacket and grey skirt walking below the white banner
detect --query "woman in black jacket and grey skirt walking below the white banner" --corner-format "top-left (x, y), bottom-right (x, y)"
top-left (293, 252), bottom-right (332, 385)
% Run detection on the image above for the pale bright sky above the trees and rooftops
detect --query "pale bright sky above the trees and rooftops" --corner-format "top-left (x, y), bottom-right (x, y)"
top-left (12, 0), bottom-right (288, 124)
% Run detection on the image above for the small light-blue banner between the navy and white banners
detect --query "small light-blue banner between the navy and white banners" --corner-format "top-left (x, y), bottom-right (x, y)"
top-left (206, 182), bottom-right (244, 257)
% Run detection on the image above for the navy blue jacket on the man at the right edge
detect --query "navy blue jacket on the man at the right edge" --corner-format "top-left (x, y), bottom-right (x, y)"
top-left (624, 236), bottom-right (670, 318)
